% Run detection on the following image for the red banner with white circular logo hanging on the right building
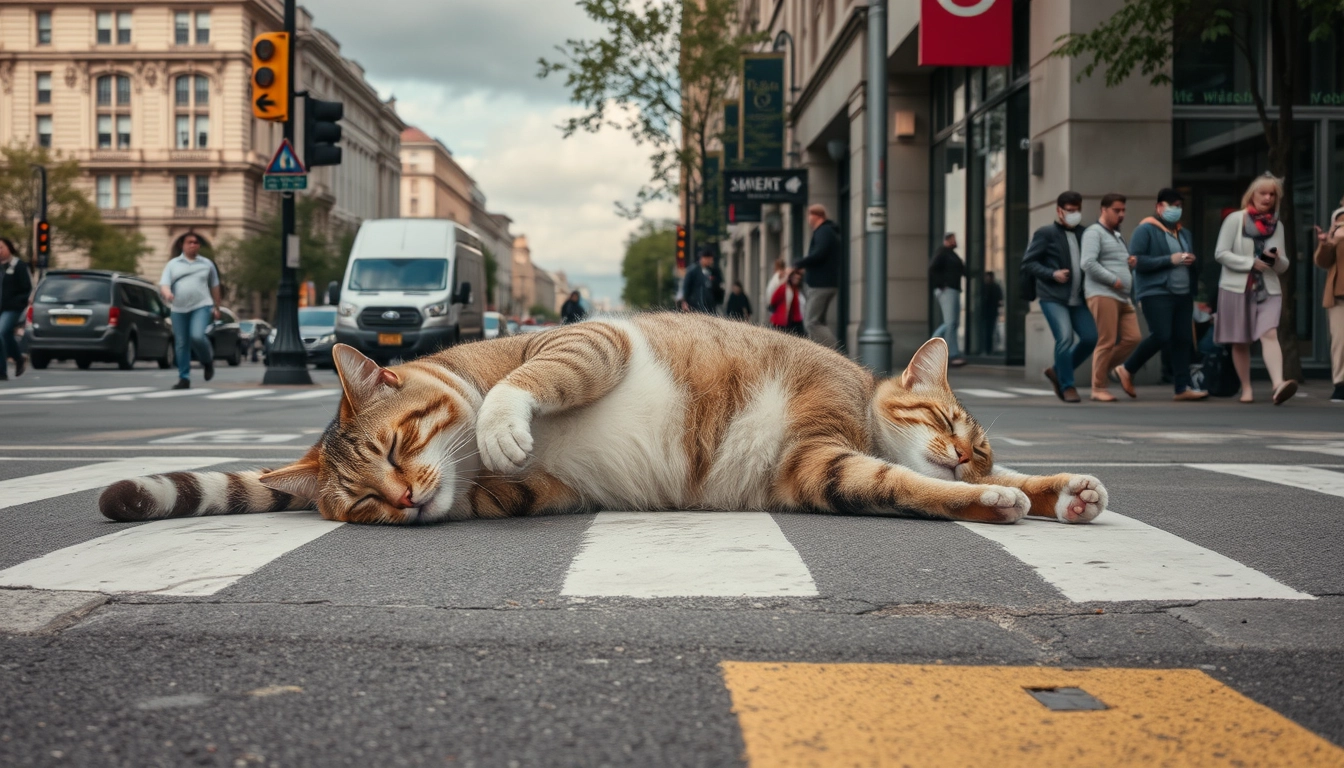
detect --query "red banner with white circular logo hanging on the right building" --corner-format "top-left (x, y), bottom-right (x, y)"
top-left (919, 0), bottom-right (1012, 67)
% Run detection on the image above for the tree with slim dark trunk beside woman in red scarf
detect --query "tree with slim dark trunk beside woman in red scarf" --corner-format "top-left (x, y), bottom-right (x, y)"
top-left (1052, 0), bottom-right (1344, 381)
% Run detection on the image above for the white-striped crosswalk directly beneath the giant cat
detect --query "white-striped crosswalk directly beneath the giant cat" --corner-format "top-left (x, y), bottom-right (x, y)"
top-left (0, 456), bottom-right (1344, 603)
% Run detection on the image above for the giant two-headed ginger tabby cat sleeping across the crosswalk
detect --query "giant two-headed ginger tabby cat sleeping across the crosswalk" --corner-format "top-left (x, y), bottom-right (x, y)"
top-left (98, 313), bottom-right (1106, 525)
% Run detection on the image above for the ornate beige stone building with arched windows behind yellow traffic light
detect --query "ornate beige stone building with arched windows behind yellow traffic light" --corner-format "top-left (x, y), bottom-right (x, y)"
top-left (0, 0), bottom-right (403, 287)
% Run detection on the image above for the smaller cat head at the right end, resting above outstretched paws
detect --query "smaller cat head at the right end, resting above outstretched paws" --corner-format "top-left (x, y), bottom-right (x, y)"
top-left (874, 339), bottom-right (995, 482)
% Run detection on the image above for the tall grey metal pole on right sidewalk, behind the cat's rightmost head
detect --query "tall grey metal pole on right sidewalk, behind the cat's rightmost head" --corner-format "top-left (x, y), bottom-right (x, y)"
top-left (859, 0), bottom-right (891, 375)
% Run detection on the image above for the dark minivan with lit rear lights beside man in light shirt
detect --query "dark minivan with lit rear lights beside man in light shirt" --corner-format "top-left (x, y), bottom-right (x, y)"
top-left (26, 269), bottom-right (173, 370)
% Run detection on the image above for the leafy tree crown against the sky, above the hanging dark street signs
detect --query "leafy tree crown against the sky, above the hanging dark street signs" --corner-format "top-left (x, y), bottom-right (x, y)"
top-left (538, 0), bottom-right (765, 219)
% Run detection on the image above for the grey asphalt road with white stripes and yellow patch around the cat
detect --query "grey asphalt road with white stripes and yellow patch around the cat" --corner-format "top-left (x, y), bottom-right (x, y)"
top-left (0, 364), bottom-right (1344, 767)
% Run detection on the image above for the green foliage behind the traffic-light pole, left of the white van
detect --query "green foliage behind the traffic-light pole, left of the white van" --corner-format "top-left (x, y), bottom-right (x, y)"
top-left (218, 198), bottom-right (355, 295)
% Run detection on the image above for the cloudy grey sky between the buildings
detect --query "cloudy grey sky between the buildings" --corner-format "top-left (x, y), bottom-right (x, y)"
top-left (304, 0), bottom-right (676, 301)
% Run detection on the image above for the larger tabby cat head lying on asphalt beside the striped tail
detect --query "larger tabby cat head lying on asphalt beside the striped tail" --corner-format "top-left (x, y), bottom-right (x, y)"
top-left (261, 344), bottom-right (478, 523)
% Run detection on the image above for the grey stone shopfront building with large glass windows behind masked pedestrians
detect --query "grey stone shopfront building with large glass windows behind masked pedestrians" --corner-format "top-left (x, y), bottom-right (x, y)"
top-left (720, 0), bottom-right (1344, 373)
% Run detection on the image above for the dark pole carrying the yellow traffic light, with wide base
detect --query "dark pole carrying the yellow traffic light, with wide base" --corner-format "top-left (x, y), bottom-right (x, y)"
top-left (261, 0), bottom-right (313, 385)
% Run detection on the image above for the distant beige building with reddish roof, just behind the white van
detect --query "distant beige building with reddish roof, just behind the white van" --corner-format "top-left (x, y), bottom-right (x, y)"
top-left (402, 126), bottom-right (513, 313)
